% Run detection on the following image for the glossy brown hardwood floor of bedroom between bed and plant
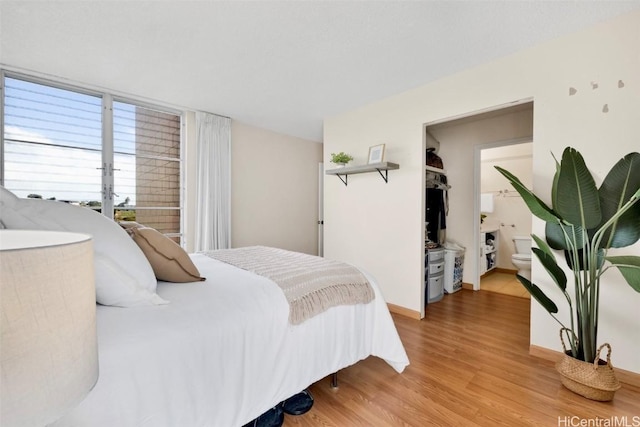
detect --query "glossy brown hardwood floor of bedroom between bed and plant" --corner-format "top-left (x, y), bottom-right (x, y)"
top-left (284, 289), bottom-right (640, 427)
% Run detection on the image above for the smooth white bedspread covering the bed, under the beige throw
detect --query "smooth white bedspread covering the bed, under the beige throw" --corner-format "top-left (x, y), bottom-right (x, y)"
top-left (55, 254), bottom-right (409, 427)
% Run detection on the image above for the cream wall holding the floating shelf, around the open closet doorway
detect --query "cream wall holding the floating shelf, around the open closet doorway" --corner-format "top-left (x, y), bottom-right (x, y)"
top-left (324, 8), bottom-right (640, 372)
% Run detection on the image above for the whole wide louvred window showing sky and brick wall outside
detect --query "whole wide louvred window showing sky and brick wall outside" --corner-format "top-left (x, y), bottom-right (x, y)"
top-left (1, 72), bottom-right (182, 242)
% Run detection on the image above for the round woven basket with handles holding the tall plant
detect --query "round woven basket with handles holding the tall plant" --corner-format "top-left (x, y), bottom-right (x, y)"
top-left (556, 331), bottom-right (620, 402)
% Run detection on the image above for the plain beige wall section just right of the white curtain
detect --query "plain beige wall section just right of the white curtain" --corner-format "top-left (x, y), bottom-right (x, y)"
top-left (231, 121), bottom-right (322, 255)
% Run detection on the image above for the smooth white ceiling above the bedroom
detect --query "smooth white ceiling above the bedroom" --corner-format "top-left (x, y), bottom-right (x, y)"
top-left (0, 0), bottom-right (640, 141)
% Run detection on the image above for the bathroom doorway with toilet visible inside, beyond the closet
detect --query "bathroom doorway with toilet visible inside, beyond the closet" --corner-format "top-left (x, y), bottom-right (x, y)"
top-left (478, 142), bottom-right (533, 298)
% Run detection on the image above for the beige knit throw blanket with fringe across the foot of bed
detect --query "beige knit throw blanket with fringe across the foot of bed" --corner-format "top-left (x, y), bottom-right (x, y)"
top-left (203, 246), bottom-right (374, 325)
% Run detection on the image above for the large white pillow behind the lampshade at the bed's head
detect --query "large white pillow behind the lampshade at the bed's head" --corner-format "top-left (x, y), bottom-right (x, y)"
top-left (0, 186), bottom-right (167, 307)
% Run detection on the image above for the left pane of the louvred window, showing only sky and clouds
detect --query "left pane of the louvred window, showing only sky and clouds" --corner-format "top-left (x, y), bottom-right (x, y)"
top-left (3, 77), bottom-right (102, 206)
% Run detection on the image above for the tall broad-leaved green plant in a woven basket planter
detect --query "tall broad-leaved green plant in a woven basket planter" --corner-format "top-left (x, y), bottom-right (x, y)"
top-left (496, 147), bottom-right (640, 400)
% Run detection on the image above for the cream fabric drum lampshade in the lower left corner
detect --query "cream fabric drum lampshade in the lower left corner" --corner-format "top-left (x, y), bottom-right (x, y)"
top-left (0, 230), bottom-right (98, 427)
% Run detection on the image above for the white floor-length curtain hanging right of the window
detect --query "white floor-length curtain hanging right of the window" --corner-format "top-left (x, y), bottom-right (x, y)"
top-left (195, 112), bottom-right (231, 251)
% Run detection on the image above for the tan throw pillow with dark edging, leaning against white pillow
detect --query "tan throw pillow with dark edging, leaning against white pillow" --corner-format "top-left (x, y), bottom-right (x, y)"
top-left (127, 224), bottom-right (205, 283)
